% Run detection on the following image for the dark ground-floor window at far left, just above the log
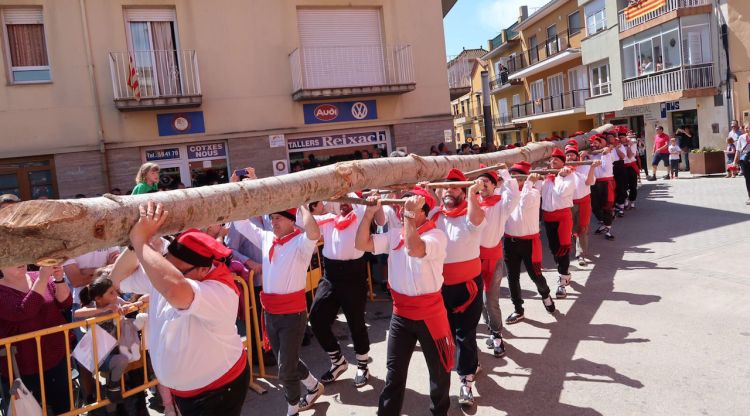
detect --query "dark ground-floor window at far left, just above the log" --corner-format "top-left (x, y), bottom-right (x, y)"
top-left (0, 158), bottom-right (57, 200)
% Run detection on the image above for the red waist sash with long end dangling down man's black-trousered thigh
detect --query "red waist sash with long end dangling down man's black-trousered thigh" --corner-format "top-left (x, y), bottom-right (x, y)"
top-left (391, 289), bottom-right (456, 372)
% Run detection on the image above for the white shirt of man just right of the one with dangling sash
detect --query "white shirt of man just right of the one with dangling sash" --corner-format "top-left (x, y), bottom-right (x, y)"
top-left (435, 202), bottom-right (487, 264)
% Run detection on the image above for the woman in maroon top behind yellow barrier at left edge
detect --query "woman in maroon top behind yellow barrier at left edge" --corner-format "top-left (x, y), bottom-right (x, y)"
top-left (0, 265), bottom-right (73, 414)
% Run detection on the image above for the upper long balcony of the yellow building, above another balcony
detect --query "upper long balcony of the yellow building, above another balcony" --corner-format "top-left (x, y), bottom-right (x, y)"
top-left (510, 31), bottom-right (582, 79)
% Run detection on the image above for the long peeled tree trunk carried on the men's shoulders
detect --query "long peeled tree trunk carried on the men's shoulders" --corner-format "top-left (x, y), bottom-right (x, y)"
top-left (0, 125), bottom-right (610, 267)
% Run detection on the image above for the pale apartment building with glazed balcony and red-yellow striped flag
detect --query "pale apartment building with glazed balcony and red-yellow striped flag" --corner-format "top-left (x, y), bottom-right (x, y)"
top-left (596, 0), bottom-right (729, 148)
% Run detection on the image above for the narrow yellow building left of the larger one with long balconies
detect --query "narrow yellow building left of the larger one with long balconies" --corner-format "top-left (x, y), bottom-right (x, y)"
top-left (482, 6), bottom-right (529, 145)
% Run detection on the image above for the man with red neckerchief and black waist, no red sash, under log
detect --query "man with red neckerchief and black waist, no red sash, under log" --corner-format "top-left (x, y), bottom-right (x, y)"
top-left (310, 194), bottom-right (385, 387)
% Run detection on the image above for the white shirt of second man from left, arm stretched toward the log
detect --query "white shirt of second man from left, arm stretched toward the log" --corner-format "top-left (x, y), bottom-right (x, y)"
top-left (234, 220), bottom-right (318, 295)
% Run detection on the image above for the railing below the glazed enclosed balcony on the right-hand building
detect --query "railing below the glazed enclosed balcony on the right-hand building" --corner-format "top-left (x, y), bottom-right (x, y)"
top-left (623, 63), bottom-right (714, 100)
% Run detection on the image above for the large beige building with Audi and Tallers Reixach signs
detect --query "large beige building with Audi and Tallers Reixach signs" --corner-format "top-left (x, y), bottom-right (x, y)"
top-left (0, 0), bottom-right (455, 199)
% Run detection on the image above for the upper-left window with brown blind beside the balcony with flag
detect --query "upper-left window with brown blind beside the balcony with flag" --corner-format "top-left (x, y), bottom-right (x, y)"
top-left (2, 8), bottom-right (52, 84)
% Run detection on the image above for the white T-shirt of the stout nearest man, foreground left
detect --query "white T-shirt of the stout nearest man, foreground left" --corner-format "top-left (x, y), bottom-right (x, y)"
top-left (120, 267), bottom-right (244, 391)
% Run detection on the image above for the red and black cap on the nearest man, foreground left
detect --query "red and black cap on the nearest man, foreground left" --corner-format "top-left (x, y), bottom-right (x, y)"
top-left (168, 228), bottom-right (232, 267)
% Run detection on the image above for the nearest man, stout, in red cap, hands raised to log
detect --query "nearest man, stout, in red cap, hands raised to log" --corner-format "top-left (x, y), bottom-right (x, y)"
top-left (111, 201), bottom-right (250, 416)
